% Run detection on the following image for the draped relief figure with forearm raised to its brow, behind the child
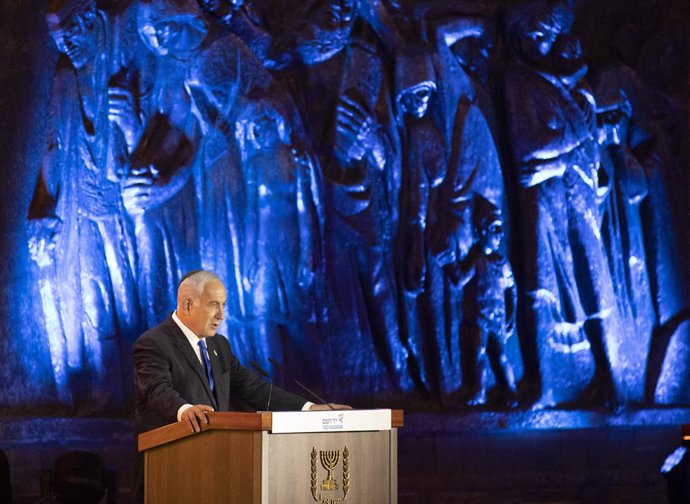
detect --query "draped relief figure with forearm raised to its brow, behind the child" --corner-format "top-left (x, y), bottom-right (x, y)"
top-left (406, 18), bottom-right (505, 397)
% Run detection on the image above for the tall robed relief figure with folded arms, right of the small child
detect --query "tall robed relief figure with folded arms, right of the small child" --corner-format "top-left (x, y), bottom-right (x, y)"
top-left (505, 1), bottom-right (616, 405)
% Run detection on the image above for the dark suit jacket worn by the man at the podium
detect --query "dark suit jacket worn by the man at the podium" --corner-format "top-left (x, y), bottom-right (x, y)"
top-left (132, 316), bottom-right (307, 432)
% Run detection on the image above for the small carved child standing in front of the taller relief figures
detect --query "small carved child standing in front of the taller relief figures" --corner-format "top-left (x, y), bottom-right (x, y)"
top-left (447, 197), bottom-right (517, 407)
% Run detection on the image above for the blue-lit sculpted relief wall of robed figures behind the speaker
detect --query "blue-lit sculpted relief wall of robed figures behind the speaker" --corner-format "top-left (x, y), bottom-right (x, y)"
top-left (0, 0), bottom-right (690, 415)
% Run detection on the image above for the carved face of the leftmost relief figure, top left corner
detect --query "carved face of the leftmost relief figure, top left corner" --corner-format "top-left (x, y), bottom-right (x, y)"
top-left (49, 7), bottom-right (98, 69)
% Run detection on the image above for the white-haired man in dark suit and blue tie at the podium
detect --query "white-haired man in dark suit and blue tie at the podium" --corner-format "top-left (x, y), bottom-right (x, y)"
top-left (132, 271), bottom-right (346, 432)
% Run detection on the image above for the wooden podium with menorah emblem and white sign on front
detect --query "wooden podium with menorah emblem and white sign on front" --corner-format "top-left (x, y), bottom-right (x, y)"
top-left (139, 410), bottom-right (403, 504)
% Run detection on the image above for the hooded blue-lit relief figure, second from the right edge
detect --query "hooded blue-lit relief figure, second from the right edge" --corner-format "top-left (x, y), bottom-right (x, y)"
top-left (597, 58), bottom-right (687, 402)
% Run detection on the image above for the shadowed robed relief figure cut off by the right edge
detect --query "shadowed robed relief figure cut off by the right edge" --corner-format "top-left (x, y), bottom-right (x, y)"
top-left (633, 36), bottom-right (690, 404)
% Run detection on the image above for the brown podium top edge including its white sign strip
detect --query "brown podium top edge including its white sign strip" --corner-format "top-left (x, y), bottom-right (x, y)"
top-left (138, 409), bottom-right (403, 452)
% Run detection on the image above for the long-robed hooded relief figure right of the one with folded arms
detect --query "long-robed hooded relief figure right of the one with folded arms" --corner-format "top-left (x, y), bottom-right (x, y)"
top-left (596, 62), bottom-right (687, 402)
